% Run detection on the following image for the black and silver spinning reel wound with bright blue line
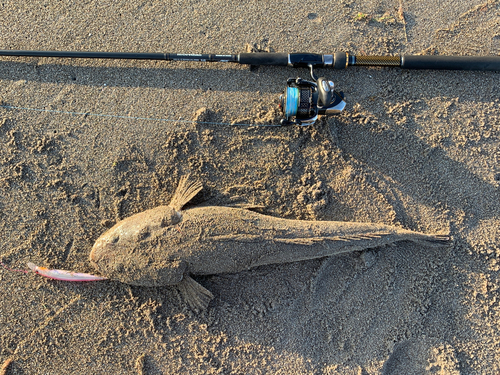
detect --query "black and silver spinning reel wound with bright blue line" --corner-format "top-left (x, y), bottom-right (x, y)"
top-left (280, 65), bottom-right (346, 126)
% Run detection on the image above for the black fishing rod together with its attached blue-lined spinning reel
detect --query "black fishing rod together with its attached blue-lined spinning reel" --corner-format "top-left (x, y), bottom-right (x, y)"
top-left (0, 50), bottom-right (500, 125)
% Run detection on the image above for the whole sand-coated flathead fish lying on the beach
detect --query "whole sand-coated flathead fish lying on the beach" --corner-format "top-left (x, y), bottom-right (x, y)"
top-left (90, 176), bottom-right (449, 310)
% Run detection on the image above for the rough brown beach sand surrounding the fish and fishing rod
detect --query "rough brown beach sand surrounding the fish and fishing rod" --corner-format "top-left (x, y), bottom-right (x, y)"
top-left (0, 0), bottom-right (500, 375)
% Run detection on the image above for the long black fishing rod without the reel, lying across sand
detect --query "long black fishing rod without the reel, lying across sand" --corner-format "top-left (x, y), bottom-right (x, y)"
top-left (0, 50), bottom-right (500, 71)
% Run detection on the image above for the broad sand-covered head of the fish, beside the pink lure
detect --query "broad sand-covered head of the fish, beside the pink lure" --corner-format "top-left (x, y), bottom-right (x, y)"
top-left (89, 206), bottom-right (185, 286)
